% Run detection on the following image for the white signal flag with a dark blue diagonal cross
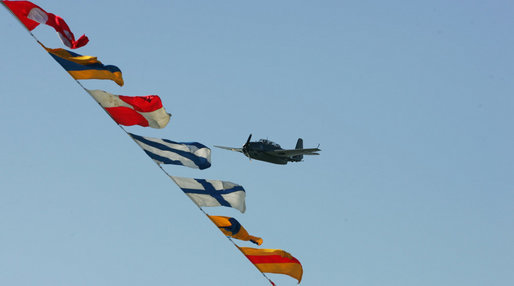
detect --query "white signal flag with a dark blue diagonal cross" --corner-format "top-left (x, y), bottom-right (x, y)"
top-left (170, 176), bottom-right (246, 213)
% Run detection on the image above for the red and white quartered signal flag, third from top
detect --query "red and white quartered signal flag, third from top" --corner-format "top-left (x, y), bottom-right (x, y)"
top-left (86, 89), bottom-right (171, 128)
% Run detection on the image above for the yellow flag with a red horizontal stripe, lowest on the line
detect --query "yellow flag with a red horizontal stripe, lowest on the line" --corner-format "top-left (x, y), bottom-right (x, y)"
top-left (239, 247), bottom-right (303, 283)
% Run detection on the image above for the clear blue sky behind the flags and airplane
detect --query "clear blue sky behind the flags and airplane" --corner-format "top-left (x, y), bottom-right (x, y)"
top-left (0, 0), bottom-right (514, 286)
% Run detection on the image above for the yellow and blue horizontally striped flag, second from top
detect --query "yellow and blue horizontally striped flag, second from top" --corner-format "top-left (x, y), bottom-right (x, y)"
top-left (41, 44), bottom-right (123, 86)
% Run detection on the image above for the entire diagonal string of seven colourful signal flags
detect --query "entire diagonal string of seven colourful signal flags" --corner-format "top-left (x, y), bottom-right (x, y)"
top-left (0, 0), bottom-right (303, 285)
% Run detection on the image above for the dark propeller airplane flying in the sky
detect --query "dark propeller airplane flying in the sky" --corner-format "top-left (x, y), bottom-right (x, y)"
top-left (214, 134), bottom-right (321, 165)
